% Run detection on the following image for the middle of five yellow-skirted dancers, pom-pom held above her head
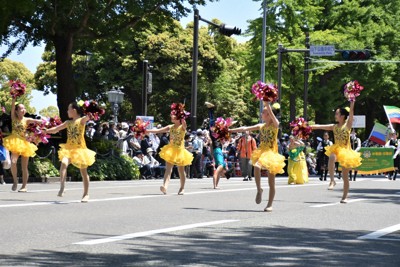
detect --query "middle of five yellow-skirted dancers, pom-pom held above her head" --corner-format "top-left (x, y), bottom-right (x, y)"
top-left (146, 104), bottom-right (193, 195)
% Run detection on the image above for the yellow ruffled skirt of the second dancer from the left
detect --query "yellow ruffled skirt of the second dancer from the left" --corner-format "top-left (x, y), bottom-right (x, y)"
top-left (58, 144), bottom-right (96, 169)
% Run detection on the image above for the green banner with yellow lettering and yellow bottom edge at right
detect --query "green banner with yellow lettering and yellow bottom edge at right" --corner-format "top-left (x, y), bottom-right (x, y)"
top-left (357, 147), bottom-right (394, 174)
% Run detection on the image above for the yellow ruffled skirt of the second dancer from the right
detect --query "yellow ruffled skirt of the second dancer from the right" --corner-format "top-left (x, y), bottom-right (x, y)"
top-left (251, 148), bottom-right (286, 174)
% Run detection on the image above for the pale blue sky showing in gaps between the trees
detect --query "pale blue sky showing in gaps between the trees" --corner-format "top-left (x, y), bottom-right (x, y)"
top-left (0, 0), bottom-right (262, 112)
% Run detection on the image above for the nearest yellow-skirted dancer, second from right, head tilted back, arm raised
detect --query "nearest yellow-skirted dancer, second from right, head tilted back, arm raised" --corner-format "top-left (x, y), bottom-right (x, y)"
top-left (230, 102), bottom-right (285, 212)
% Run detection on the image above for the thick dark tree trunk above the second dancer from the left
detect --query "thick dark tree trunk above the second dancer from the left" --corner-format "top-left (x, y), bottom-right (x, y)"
top-left (53, 35), bottom-right (77, 121)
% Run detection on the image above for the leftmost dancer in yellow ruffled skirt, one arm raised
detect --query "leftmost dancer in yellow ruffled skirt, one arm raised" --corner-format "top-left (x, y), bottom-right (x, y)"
top-left (3, 97), bottom-right (42, 192)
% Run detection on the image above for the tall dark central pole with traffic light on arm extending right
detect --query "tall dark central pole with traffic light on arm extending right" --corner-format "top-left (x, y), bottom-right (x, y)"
top-left (190, 7), bottom-right (242, 131)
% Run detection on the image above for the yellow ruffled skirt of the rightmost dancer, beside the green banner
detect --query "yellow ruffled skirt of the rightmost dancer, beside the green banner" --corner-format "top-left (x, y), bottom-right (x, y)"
top-left (325, 144), bottom-right (361, 169)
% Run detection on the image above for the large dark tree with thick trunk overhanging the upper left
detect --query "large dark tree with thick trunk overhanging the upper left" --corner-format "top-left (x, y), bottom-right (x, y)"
top-left (0, 0), bottom-right (216, 119)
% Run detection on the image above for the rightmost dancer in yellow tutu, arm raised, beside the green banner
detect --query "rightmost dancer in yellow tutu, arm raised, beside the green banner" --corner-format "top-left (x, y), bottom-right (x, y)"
top-left (311, 100), bottom-right (361, 203)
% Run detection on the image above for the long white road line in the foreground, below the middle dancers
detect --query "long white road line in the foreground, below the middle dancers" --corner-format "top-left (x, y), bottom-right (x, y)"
top-left (74, 220), bottom-right (238, 245)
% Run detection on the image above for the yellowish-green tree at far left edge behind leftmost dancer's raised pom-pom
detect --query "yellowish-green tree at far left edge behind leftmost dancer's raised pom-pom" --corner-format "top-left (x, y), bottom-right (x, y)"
top-left (0, 59), bottom-right (36, 114)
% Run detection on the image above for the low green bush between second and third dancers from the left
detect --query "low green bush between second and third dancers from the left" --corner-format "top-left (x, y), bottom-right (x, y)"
top-left (67, 155), bottom-right (139, 181)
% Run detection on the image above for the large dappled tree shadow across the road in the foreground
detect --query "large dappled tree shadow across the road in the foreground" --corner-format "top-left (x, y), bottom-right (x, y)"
top-left (0, 226), bottom-right (400, 266)
